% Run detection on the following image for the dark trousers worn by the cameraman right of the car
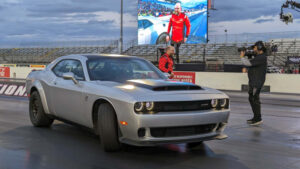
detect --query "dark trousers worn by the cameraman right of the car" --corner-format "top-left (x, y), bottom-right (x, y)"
top-left (248, 85), bottom-right (261, 121)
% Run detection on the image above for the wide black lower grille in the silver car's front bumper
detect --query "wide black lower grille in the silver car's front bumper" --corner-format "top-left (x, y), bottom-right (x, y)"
top-left (150, 124), bottom-right (216, 137)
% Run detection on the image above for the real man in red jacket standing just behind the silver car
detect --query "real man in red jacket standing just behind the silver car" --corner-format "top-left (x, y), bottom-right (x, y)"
top-left (158, 46), bottom-right (175, 79)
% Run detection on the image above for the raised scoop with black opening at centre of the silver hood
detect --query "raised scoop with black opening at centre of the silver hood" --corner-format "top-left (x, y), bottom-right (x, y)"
top-left (126, 79), bottom-right (202, 91)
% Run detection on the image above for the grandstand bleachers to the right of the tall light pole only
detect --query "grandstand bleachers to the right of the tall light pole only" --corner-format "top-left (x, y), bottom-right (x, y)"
top-left (124, 39), bottom-right (300, 67)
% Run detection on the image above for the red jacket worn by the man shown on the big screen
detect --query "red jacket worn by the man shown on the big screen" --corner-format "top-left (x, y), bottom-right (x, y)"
top-left (168, 13), bottom-right (191, 43)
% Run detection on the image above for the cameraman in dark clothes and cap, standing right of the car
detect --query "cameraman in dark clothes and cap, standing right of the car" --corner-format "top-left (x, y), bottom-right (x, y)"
top-left (239, 41), bottom-right (267, 126)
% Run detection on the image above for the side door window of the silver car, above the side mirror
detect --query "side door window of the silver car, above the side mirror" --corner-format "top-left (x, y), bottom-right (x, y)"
top-left (52, 60), bottom-right (85, 80)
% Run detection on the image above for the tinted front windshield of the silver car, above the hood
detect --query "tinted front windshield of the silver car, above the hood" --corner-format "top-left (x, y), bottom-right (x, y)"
top-left (87, 58), bottom-right (166, 82)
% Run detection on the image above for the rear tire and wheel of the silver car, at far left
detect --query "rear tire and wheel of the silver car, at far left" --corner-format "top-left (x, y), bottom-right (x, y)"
top-left (29, 91), bottom-right (54, 127)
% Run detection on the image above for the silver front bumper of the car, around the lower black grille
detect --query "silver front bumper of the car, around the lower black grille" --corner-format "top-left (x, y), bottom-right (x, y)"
top-left (120, 110), bottom-right (230, 146)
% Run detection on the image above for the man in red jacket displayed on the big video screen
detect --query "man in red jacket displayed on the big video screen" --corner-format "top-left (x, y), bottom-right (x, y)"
top-left (166, 3), bottom-right (191, 63)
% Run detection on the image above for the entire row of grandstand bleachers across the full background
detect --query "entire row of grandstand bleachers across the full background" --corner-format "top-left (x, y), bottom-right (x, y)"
top-left (0, 39), bottom-right (300, 70)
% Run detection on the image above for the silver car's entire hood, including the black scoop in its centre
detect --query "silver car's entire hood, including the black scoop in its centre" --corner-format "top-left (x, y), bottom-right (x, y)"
top-left (92, 79), bottom-right (224, 101)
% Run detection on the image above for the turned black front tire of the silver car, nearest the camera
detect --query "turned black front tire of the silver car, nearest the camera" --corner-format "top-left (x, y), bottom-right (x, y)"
top-left (98, 103), bottom-right (121, 152)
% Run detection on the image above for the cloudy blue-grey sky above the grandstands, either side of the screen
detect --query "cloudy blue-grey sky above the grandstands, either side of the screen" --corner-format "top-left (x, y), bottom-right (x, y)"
top-left (0, 0), bottom-right (300, 46)
